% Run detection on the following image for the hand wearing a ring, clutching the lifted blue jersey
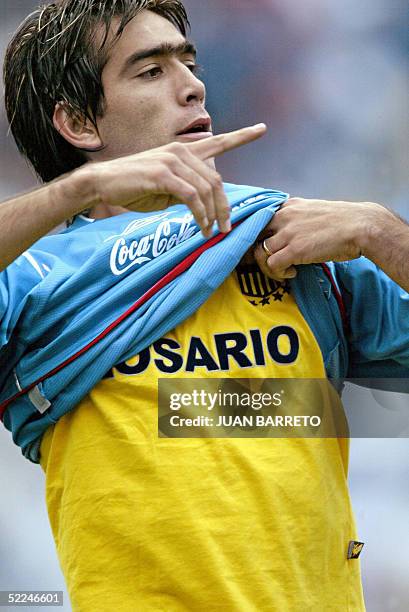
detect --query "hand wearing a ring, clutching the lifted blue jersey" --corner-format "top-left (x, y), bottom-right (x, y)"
top-left (254, 198), bottom-right (391, 280)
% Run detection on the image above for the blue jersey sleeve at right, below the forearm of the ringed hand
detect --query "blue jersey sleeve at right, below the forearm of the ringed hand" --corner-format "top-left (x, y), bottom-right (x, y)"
top-left (335, 257), bottom-right (409, 378)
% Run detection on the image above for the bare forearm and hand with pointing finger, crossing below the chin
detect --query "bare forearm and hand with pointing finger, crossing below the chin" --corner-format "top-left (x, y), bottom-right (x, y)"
top-left (0, 124), bottom-right (266, 271)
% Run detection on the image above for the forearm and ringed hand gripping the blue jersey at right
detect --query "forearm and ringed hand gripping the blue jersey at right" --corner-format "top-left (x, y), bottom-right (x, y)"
top-left (255, 198), bottom-right (409, 292)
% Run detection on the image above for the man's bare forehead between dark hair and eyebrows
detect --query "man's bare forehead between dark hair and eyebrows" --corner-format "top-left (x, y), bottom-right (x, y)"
top-left (104, 10), bottom-right (185, 77)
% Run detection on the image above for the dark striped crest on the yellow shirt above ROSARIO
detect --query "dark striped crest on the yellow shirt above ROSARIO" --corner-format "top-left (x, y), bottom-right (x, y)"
top-left (236, 264), bottom-right (290, 306)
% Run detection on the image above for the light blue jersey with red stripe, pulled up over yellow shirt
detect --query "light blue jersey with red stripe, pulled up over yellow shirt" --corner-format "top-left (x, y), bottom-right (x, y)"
top-left (0, 184), bottom-right (409, 462)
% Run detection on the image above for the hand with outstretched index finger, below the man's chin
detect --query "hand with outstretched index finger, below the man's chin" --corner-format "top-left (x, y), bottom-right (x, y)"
top-left (73, 124), bottom-right (266, 237)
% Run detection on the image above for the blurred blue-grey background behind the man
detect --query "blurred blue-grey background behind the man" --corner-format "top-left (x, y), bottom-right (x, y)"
top-left (0, 0), bottom-right (409, 612)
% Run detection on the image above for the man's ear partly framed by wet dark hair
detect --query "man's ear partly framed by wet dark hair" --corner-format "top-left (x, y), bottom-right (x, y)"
top-left (53, 102), bottom-right (104, 151)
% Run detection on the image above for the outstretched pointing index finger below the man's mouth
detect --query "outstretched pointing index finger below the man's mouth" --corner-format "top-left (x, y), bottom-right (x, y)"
top-left (188, 123), bottom-right (267, 160)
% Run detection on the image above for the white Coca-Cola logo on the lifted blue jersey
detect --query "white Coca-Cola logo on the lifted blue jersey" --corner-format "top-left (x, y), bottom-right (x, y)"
top-left (109, 213), bottom-right (198, 276)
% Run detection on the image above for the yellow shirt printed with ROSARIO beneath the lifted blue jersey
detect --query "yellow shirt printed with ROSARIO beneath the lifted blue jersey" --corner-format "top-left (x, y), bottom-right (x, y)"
top-left (41, 269), bottom-right (365, 612)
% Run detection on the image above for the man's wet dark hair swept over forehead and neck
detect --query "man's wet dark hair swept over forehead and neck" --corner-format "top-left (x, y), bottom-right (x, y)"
top-left (3, 0), bottom-right (189, 181)
